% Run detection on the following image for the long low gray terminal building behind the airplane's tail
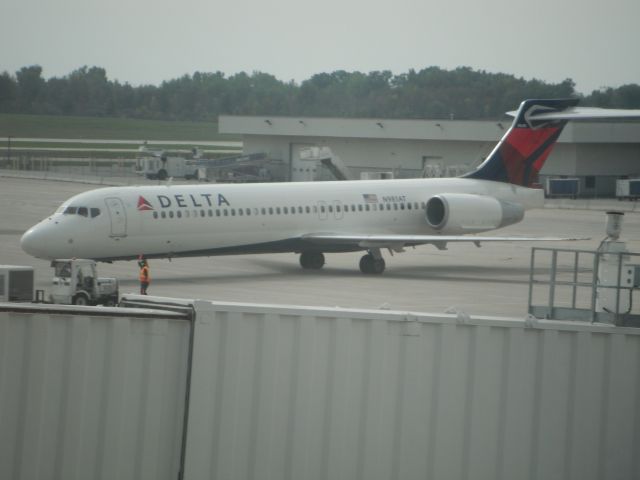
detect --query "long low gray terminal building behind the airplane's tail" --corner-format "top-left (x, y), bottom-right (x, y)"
top-left (219, 115), bottom-right (640, 197)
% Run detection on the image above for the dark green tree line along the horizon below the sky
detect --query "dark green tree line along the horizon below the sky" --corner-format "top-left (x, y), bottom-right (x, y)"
top-left (0, 65), bottom-right (640, 121)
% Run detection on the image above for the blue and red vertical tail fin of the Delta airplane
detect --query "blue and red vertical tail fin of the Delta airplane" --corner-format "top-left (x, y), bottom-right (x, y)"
top-left (463, 98), bottom-right (579, 187)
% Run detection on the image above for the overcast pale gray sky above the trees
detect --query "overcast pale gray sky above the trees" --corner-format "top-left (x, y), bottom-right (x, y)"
top-left (0, 0), bottom-right (640, 94)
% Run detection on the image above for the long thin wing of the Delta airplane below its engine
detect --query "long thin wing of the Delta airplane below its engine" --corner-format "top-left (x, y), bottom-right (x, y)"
top-left (302, 233), bottom-right (589, 251)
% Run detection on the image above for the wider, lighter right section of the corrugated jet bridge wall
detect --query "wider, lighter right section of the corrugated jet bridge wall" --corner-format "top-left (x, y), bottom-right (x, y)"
top-left (185, 302), bottom-right (640, 480)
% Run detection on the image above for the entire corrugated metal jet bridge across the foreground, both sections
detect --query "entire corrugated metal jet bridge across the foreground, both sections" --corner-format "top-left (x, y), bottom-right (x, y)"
top-left (0, 299), bottom-right (640, 480)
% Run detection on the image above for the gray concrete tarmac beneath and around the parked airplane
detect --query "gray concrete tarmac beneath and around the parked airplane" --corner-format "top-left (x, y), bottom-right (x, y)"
top-left (0, 178), bottom-right (640, 318)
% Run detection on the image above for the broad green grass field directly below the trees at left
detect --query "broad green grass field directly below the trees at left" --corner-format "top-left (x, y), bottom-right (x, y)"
top-left (0, 113), bottom-right (241, 143)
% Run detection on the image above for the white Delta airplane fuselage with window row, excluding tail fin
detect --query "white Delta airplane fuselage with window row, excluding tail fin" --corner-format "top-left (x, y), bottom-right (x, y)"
top-left (22, 178), bottom-right (543, 261)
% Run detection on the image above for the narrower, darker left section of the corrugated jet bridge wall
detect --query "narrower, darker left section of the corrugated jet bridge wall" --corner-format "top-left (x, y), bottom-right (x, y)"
top-left (0, 307), bottom-right (190, 480)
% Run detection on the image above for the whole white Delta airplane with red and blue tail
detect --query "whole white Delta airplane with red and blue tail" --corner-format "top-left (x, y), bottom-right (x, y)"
top-left (21, 99), bottom-right (640, 274)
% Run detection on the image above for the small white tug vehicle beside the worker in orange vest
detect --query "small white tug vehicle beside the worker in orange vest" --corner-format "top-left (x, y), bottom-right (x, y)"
top-left (49, 258), bottom-right (118, 305)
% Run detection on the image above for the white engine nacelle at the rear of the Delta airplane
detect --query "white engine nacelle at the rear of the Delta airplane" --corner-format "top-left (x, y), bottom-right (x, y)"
top-left (425, 193), bottom-right (524, 235)
